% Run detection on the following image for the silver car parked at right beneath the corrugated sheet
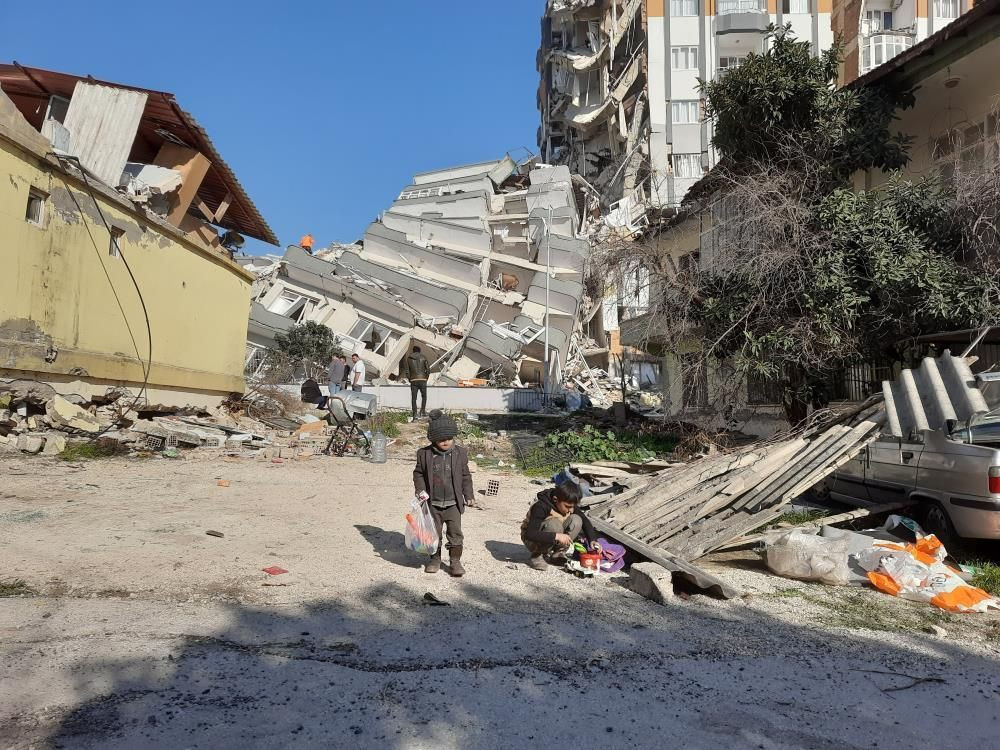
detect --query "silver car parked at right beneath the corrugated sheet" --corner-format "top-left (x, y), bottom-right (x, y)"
top-left (827, 417), bottom-right (1000, 547)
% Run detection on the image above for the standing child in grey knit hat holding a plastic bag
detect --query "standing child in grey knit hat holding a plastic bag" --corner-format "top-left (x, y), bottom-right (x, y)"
top-left (413, 409), bottom-right (473, 577)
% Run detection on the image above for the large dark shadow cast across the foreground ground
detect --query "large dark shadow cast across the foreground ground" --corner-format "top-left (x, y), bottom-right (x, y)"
top-left (9, 576), bottom-right (1000, 750)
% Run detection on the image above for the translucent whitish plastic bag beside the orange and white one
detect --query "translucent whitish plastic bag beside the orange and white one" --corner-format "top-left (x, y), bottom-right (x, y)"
top-left (764, 529), bottom-right (851, 586)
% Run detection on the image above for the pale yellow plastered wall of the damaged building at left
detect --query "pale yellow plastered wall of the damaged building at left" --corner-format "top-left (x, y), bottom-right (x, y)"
top-left (0, 138), bottom-right (251, 403)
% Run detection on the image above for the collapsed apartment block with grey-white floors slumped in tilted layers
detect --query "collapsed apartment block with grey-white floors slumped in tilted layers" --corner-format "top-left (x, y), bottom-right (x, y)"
top-left (238, 156), bottom-right (607, 390)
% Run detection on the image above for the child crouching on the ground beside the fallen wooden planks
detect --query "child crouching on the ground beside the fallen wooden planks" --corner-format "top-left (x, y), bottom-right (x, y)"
top-left (521, 481), bottom-right (597, 570)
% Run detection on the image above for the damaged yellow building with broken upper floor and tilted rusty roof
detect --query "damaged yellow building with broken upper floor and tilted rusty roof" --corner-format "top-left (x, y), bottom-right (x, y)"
top-left (0, 65), bottom-right (277, 409)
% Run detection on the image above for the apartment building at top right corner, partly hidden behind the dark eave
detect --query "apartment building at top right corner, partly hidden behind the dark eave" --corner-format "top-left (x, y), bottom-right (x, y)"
top-left (832, 0), bottom-right (973, 84)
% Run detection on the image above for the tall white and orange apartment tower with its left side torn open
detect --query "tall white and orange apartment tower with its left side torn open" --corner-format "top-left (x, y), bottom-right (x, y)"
top-left (538, 0), bottom-right (836, 227)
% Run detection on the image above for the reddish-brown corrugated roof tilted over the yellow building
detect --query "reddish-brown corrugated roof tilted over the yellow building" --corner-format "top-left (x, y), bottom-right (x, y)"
top-left (0, 62), bottom-right (278, 245)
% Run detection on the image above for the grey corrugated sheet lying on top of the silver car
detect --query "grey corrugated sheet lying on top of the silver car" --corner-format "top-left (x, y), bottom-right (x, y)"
top-left (882, 350), bottom-right (989, 438)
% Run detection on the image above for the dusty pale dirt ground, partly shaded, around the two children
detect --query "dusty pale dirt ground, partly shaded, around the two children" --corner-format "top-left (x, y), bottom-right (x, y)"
top-left (0, 446), bottom-right (1000, 749)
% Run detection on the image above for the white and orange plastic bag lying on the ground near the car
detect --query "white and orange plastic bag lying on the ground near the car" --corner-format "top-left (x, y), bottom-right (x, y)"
top-left (855, 534), bottom-right (1000, 612)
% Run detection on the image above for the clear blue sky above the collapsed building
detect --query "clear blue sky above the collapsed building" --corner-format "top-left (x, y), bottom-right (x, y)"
top-left (0, 0), bottom-right (544, 252)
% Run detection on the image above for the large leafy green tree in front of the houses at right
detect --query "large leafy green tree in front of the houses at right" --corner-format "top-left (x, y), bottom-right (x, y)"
top-left (628, 29), bottom-right (998, 424)
